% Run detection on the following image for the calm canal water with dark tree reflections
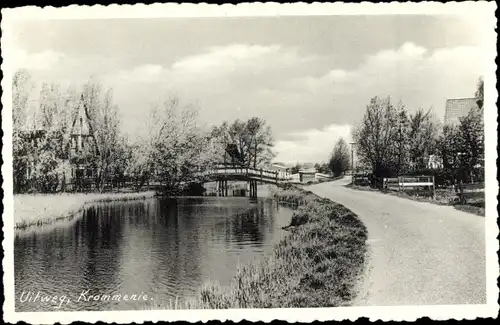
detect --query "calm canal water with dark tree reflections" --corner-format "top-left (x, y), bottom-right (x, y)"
top-left (14, 197), bottom-right (292, 311)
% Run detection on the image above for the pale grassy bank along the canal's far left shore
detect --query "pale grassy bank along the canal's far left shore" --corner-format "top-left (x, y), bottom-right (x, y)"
top-left (14, 191), bottom-right (155, 229)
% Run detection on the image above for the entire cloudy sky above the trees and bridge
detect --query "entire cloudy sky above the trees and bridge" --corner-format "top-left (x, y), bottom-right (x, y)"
top-left (12, 15), bottom-right (486, 163)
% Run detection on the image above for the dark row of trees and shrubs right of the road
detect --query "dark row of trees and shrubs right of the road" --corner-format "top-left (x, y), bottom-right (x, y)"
top-left (353, 78), bottom-right (484, 186)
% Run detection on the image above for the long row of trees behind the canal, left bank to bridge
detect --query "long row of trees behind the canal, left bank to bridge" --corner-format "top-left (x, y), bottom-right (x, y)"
top-left (12, 69), bottom-right (274, 195)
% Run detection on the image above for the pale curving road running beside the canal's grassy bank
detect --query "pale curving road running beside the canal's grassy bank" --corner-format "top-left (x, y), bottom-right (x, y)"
top-left (307, 178), bottom-right (486, 306)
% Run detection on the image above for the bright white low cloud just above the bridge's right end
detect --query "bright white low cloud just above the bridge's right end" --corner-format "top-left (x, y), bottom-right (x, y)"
top-left (275, 124), bottom-right (351, 163)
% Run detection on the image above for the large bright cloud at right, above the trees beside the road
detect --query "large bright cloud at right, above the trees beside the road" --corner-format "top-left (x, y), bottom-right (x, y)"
top-left (283, 42), bottom-right (485, 123)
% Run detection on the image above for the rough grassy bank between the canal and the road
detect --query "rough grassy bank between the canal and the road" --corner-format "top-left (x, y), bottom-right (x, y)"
top-left (187, 185), bottom-right (367, 309)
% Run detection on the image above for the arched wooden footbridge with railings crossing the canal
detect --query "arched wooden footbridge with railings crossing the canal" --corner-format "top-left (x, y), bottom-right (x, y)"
top-left (201, 165), bottom-right (291, 198)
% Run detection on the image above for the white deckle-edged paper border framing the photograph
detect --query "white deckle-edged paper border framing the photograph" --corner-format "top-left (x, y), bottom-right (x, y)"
top-left (1, 2), bottom-right (499, 324)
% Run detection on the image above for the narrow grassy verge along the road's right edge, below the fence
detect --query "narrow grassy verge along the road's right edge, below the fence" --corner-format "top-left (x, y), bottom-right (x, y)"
top-left (346, 184), bottom-right (485, 217)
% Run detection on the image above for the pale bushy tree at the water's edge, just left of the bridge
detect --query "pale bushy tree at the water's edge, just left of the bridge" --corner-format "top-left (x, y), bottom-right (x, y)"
top-left (139, 98), bottom-right (220, 195)
